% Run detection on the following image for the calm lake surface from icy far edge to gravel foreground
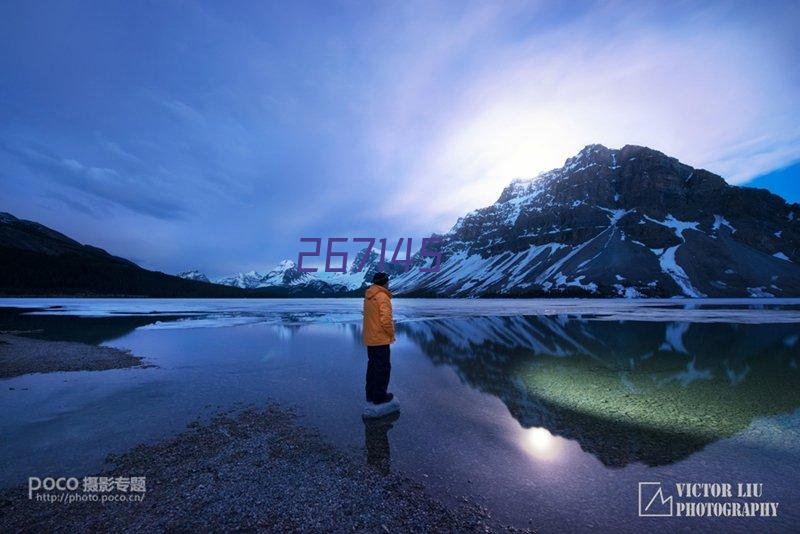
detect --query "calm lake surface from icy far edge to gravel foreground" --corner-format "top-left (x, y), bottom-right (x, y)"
top-left (0, 299), bottom-right (800, 532)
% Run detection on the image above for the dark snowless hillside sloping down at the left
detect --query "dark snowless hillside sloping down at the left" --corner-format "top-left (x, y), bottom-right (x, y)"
top-left (0, 213), bottom-right (247, 297)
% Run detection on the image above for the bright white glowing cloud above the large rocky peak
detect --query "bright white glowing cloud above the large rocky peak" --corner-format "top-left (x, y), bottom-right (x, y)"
top-left (360, 2), bottom-right (800, 229)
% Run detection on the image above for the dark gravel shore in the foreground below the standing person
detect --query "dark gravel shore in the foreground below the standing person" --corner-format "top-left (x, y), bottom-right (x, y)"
top-left (0, 405), bottom-right (528, 532)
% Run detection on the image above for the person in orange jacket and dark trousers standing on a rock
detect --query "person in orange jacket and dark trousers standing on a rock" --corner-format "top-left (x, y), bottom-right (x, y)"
top-left (362, 273), bottom-right (395, 404)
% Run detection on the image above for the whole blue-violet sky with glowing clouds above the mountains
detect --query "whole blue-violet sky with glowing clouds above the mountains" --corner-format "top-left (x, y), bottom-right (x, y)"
top-left (0, 0), bottom-right (800, 276)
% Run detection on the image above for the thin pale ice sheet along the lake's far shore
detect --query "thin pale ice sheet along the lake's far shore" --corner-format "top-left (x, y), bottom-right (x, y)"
top-left (0, 298), bottom-right (800, 328)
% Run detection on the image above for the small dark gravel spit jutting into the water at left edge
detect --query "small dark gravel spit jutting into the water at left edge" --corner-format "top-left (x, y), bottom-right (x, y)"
top-left (0, 333), bottom-right (148, 378)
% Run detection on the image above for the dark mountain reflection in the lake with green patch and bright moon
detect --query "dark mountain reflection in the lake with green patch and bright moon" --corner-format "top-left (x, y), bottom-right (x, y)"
top-left (399, 317), bottom-right (800, 467)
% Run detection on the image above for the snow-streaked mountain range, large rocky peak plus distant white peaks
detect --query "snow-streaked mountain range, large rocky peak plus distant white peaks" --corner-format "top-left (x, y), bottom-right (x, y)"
top-left (181, 145), bottom-right (800, 297)
